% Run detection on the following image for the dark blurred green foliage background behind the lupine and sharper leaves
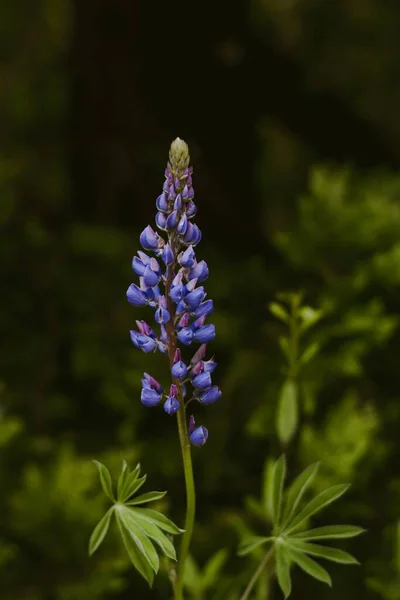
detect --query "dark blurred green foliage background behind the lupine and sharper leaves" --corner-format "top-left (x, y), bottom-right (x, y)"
top-left (0, 0), bottom-right (400, 600)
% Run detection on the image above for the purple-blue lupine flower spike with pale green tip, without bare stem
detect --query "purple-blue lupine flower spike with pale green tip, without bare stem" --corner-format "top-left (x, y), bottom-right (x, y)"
top-left (126, 138), bottom-right (221, 446)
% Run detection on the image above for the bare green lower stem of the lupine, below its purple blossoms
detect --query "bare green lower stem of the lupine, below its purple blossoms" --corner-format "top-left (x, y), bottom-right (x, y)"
top-left (174, 402), bottom-right (196, 600)
